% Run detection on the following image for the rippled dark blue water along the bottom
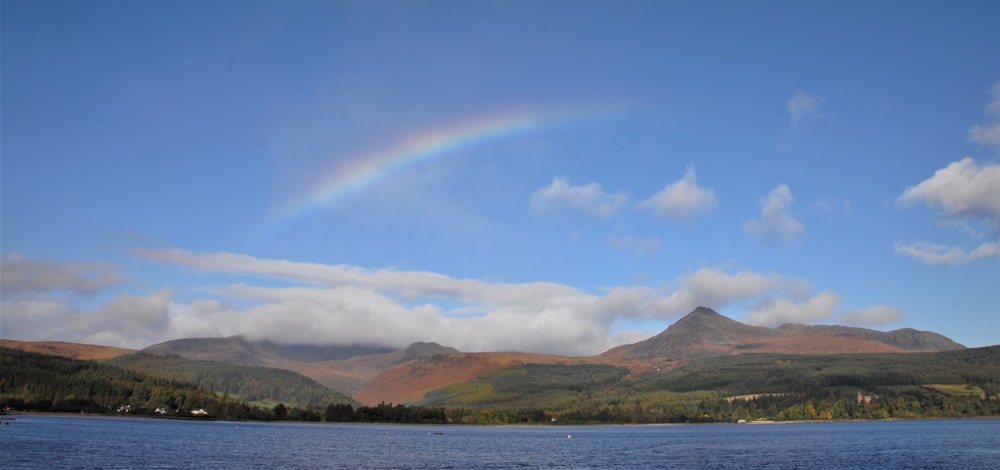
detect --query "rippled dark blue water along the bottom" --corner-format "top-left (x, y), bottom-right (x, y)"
top-left (0, 416), bottom-right (1000, 469)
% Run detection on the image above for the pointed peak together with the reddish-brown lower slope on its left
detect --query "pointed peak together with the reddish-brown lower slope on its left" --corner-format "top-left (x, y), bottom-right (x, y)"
top-left (353, 307), bottom-right (964, 404)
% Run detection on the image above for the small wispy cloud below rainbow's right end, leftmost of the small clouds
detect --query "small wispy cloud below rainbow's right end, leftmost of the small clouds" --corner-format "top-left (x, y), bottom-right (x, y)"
top-left (531, 178), bottom-right (628, 217)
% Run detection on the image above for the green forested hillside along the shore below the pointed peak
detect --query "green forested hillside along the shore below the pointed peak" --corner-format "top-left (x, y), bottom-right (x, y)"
top-left (419, 346), bottom-right (1000, 423)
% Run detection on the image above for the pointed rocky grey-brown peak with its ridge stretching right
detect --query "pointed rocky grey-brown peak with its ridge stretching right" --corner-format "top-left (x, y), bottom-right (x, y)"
top-left (599, 307), bottom-right (964, 362)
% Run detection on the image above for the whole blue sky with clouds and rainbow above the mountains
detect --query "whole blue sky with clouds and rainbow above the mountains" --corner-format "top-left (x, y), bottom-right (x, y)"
top-left (0, 0), bottom-right (1000, 355)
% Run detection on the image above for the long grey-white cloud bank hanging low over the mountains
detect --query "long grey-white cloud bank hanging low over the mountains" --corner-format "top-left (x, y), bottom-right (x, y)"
top-left (0, 250), bottom-right (908, 355)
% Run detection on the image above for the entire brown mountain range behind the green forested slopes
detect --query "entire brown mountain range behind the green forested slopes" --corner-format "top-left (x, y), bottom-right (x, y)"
top-left (1, 307), bottom-right (965, 405)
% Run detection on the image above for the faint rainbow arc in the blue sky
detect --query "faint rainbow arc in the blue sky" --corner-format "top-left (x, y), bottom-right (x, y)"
top-left (266, 108), bottom-right (608, 237)
